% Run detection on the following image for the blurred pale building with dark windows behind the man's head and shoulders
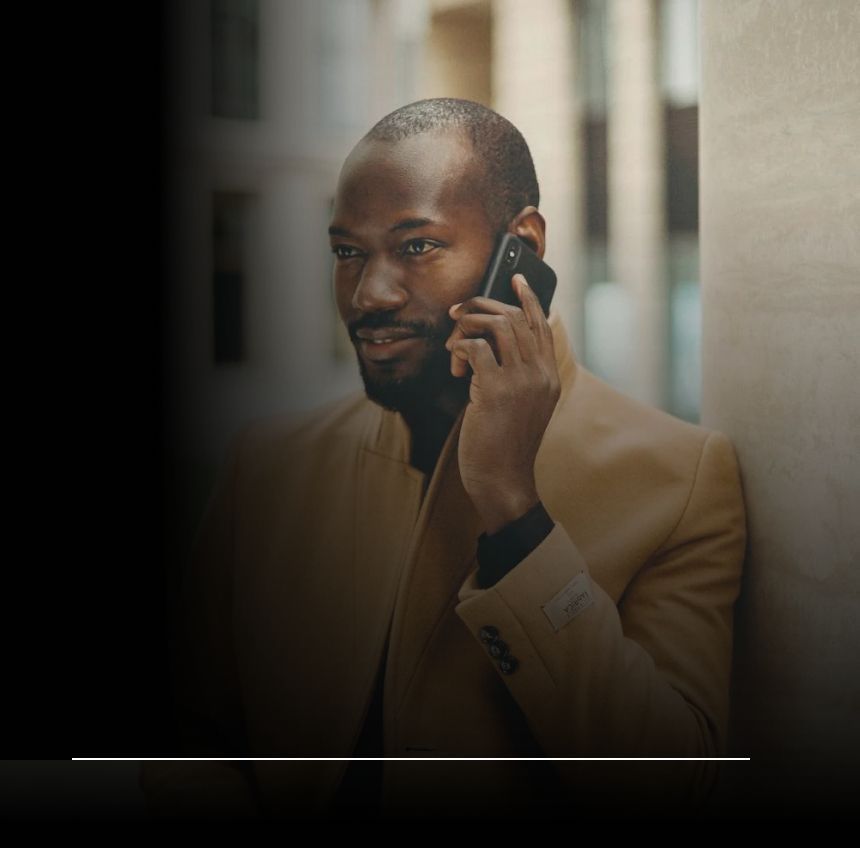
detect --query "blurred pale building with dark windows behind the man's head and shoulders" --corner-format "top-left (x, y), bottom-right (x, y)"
top-left (166, 0), bottom-right (700, 510)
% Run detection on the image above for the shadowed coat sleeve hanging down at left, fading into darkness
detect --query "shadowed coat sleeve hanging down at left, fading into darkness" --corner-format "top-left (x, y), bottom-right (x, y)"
top-left (139, 429), bottom-right (260, 818)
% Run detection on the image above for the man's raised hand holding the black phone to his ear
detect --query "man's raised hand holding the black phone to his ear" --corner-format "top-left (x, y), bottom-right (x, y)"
top-left (445, 274), bottom-right (561, 535)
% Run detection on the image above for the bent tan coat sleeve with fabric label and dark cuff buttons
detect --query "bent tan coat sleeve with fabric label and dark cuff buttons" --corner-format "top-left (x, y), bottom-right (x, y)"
top-left (456, 432), bottom-right (746, 799)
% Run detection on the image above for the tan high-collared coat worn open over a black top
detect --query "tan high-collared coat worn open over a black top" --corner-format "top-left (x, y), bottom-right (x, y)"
top-left (141, 313), bottom-right (745, 815)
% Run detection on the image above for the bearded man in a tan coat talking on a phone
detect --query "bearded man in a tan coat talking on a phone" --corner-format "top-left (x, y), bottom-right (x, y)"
top-left (142, 99), bottom-right (745, 816)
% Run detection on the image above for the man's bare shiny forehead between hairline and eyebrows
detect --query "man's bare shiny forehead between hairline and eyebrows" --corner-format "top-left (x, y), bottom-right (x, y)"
top-left (334, 131), bottom-right (488, 225)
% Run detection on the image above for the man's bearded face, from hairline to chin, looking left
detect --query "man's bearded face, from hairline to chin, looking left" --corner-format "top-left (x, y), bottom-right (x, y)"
top-left (329, 133), bottom-right (494, 412)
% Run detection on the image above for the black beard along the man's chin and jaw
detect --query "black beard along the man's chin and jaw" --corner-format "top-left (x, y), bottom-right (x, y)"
top-left (358, 321), bottom-right (470, 415)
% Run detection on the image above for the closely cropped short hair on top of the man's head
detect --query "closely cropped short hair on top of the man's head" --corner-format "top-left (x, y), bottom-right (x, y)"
top-left (364, 97), bottom-right (540, 233)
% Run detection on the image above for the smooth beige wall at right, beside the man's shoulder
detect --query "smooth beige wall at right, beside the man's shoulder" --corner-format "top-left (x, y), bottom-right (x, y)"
top-left (700, 0), bottom-right (860, 800)
